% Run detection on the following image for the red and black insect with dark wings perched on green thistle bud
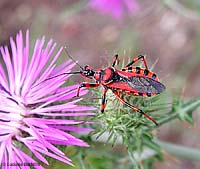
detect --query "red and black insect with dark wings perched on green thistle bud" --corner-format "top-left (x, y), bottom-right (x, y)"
top-left (71, 55), bottom-right (165, 125)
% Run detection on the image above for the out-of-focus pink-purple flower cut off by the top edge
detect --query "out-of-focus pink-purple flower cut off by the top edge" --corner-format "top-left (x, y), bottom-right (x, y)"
top-left (89, 0), bottom-right (139, 20)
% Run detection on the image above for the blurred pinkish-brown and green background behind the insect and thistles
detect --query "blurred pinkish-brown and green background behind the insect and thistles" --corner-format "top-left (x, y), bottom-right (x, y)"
top-left (0, 0), bottom-right (200, 169)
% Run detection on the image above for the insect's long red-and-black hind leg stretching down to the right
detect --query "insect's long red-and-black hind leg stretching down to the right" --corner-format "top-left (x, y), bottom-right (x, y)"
top-left (112, 90), bottom-right (158, 125)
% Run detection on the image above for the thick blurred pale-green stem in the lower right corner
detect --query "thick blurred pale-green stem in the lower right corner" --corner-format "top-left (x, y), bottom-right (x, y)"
top-left (155, 140), bottom-right (200, 161)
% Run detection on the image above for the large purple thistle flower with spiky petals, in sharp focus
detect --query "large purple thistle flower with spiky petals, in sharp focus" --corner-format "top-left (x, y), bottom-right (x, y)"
top-left (0, 31), bottom-right (94, 169)
